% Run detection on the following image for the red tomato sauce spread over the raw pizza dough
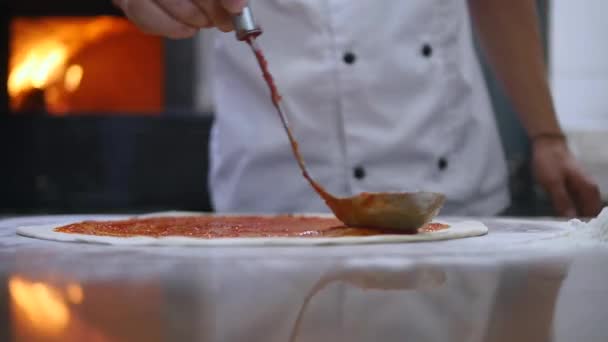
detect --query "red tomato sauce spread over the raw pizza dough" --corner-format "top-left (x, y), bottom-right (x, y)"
top-left (55, 215), bottom-right (449, 239)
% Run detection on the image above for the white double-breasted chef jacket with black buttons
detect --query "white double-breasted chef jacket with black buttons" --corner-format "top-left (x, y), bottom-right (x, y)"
top-left (210, 0), bottom-right (509, 215)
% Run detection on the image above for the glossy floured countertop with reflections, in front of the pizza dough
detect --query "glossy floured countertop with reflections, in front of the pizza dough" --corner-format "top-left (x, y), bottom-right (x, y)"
top-left (0, 217), bottom-right (608, 342)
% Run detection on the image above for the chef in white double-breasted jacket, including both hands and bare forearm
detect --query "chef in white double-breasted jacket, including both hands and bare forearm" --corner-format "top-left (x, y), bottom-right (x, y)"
top-left (116, 0), bottom-right (600, 217)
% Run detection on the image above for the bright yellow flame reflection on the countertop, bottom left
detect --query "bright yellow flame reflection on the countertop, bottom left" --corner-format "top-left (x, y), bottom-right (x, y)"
top-left (8, 276), bottom-right (70, 335)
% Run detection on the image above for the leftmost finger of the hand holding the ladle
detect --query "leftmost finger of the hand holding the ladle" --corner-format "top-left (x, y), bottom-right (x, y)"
top-left (122, 0), bottom-right (197, 38)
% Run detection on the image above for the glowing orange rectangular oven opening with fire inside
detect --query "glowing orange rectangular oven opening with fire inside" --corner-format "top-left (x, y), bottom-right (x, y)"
top-left (7, 16), bottom-right (165, 116)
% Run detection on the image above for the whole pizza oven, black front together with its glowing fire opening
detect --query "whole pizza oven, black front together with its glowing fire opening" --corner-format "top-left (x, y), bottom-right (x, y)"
top-left (0, 0), bottom-right (211, 212)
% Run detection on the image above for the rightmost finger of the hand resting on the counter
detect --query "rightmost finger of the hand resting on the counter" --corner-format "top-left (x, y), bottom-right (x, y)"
top-left (566, 168), bottom-right (602, 217)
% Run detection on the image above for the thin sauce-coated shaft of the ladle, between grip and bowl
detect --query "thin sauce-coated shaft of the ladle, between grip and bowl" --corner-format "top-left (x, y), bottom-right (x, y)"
top-left (245, 36), bottom-right (340, 210)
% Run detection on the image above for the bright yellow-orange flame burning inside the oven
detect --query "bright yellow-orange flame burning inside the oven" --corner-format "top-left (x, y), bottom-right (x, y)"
top-left (7, 16), bottom-right (131, 108)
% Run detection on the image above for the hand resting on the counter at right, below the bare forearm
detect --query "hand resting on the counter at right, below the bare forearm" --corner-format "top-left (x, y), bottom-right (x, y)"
top-left (532, 139), bottom-right (602, 218)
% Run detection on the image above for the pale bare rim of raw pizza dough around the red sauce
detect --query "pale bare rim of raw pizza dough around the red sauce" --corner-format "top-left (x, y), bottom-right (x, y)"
top-left (17, 212), bottom-right (488, 246)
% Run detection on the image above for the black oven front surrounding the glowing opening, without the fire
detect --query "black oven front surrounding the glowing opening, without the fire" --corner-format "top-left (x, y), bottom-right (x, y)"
top-left (0, 0), bottom-right (212, 213)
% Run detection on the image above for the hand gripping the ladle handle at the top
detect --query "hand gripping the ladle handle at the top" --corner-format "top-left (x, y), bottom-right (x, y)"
top-left (113, 0), bottom-right (247, 39)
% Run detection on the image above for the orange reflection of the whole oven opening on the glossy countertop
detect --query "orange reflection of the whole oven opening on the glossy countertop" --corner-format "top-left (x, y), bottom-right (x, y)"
top-left (8, 275), bottom-right (163, 341)
